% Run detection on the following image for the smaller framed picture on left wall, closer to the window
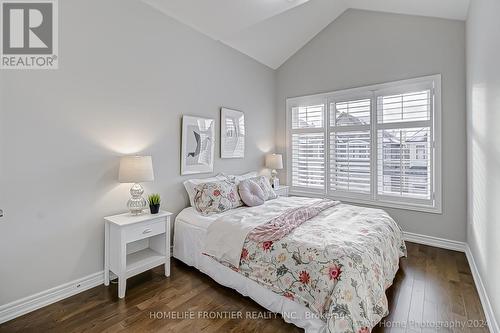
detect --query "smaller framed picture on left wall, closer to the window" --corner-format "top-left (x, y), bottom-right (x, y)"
top-left (220, 107), bottom-right (245, 158)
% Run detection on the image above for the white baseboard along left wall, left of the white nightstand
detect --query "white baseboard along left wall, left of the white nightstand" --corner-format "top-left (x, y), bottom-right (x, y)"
top-left (0, 271), bottom-right (104, 324)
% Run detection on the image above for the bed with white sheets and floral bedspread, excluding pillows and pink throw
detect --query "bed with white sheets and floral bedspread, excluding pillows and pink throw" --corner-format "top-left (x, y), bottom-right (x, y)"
top-left (173, 197), bottom-right (406, 333)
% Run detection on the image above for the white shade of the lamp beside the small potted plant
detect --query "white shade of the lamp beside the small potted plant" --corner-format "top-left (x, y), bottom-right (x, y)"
top-left (118, 156), bottom-right (154, 183)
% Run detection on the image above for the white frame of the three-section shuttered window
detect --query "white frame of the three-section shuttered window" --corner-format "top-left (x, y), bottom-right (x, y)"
top-left (285, 74), bottom-right (442, 214)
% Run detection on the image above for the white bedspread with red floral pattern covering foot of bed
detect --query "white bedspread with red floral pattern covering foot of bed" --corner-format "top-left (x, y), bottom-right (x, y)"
top-left (234, 204), bottom-right (406, 333)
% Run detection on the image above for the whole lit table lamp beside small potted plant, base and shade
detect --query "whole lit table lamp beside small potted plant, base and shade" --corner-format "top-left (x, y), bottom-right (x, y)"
top-left (118, 156), bottom-right (154, 215)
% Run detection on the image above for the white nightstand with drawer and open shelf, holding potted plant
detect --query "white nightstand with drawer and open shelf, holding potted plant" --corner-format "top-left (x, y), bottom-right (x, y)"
top-left (104, 211), bottom-right (172, 298)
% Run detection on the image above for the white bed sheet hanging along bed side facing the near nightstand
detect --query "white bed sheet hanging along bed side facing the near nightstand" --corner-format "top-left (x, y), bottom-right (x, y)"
top-left (173, 207), bottom-right (326, 333)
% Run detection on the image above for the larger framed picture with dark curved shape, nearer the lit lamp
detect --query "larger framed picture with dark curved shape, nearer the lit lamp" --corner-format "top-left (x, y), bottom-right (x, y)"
top-left (181, 116), bottom-right (215, 175)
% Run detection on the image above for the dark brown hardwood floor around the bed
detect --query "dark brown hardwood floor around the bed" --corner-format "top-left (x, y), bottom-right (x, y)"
top-left (0, 243), bottom-right (488, 333)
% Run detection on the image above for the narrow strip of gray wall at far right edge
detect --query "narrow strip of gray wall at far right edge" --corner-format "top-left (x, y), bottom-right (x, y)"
top-left (467, 0), bottom-right (500, 324)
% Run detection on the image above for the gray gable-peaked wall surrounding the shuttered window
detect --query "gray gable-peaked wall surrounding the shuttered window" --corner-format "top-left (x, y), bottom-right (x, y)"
top-left (276, 10), bottom-right (466, 241)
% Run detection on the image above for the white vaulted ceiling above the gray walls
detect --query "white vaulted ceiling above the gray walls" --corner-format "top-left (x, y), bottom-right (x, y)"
top-left (143, 0), bottom-right (469, 69)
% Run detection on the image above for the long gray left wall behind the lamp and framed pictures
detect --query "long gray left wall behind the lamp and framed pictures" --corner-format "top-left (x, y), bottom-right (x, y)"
top-left (0, 0), bottom-right (275, 305)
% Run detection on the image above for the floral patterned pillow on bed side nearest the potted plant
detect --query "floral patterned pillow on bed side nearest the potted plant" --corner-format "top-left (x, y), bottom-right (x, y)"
top-left (194, 180), bottom-right (243, 214)
